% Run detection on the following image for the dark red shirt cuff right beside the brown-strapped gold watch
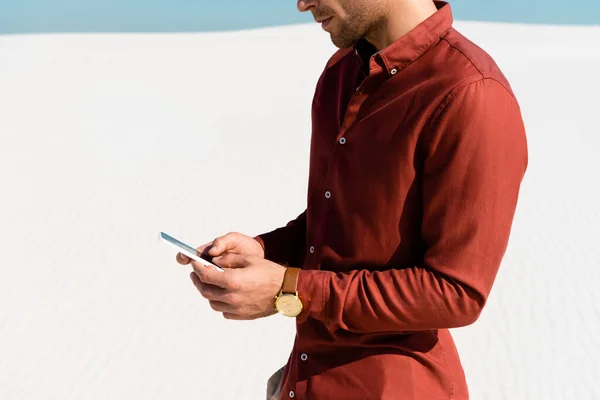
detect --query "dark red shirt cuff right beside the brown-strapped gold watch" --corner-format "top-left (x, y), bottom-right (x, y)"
top-left (297, 269), bottom-right (333, 323)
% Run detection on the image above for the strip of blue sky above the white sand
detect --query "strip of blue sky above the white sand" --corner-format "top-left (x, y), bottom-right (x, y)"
top-left (0, 0), bottom-right (600, 34)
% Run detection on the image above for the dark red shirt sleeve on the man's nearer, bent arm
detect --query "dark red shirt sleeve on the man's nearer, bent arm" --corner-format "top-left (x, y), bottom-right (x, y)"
top-left (298, 78), bottom-right (528, 333)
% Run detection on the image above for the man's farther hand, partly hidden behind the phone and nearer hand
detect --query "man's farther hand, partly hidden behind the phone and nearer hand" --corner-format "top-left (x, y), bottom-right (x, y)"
top-left (176, 232), bottom-right (265, 265)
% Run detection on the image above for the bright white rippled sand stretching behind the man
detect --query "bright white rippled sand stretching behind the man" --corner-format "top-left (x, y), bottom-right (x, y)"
top-left (0, 23), bottom-right (600, 400)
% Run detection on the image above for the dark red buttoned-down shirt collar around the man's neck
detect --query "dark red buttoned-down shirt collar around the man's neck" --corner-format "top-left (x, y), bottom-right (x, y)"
top-left (354, 0), bottom-right (454, 75)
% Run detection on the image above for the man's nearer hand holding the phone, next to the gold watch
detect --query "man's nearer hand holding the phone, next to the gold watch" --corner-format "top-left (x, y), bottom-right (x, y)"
top-left (190, 253), bottom-right (286, 320)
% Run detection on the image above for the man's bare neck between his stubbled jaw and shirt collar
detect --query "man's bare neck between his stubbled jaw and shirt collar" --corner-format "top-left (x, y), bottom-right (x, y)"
top-left (365, 0), bottom-right (437, 51)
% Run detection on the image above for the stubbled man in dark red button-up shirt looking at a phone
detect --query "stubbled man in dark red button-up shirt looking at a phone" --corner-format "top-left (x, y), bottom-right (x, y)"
top-left (178, 0), bottom-right (528, 400)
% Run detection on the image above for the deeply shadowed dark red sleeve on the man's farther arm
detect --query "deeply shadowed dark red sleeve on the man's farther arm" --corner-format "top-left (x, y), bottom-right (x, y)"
top-left (255, 210), bottom-right (306, 267)
